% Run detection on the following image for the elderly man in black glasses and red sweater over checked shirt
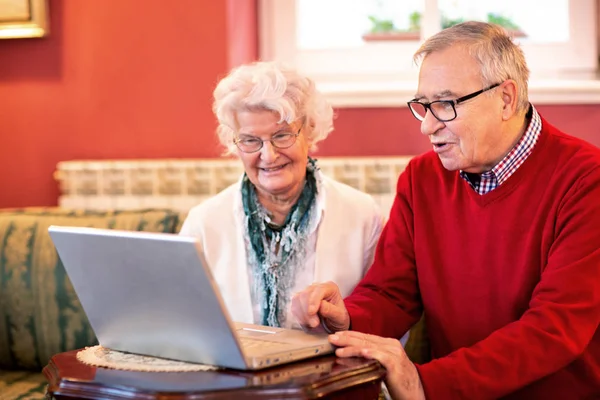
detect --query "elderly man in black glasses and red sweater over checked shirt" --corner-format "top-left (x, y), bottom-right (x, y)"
top-left (292, 22), bottom-right (600, 399)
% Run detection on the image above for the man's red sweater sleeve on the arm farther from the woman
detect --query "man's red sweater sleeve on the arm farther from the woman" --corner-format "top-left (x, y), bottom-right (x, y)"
top-left (414, 166), bottom-right (600, 399)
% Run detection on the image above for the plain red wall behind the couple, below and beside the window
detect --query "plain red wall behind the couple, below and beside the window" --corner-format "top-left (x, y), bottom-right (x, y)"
top-left (0, 0), bottom-right (600, 207)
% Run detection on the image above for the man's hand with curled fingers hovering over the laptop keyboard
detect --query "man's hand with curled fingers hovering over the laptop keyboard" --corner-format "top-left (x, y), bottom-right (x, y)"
top-left (292, 282), bottom-right (350, 332)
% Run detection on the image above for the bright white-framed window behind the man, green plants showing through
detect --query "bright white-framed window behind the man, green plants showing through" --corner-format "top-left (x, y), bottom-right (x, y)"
top-left (259, 0), bottom-right (600, 107)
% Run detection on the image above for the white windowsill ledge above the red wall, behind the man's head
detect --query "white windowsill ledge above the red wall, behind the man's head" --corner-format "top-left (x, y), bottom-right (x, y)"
top-left (317, 78), bottom-right (600, 108)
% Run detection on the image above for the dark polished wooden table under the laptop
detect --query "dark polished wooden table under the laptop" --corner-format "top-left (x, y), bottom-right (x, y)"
top-left (43, 350), bottom-right (385, 400)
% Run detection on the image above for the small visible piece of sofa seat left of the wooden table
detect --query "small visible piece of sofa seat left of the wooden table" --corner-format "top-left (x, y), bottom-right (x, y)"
top-left (0, 370), bottom-right (48, 400)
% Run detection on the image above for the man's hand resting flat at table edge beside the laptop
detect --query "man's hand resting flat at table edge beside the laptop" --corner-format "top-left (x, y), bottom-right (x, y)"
top-left (329, 331), bottom-right (425, 400)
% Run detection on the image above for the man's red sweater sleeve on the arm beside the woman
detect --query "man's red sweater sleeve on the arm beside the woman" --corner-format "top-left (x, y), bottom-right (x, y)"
top-left (345, 159), bottom-right (422, 338)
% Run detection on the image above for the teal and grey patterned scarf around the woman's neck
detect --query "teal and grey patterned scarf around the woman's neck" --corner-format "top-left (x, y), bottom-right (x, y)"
top-left (242, 158), bottom-right (318, 327)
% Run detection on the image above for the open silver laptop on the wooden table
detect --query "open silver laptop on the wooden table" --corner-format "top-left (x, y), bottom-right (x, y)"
top-left (48, 226), bottom-right (334, 370)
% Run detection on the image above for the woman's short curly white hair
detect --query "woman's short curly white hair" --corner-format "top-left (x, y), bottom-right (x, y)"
top-left (213, 61), bottom-right (333, 154)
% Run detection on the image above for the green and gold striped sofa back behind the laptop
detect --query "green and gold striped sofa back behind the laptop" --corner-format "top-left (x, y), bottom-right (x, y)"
top-left (0, 209), bottom-right (179, 371)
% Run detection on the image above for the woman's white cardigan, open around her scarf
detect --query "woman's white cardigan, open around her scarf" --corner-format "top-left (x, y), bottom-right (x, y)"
top-left (180, 174), bottom-right (384, 327)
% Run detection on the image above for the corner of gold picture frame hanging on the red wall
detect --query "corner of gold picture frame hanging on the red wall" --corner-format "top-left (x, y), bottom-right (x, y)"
top-left (0, 0), bottom-right (49, 39)
